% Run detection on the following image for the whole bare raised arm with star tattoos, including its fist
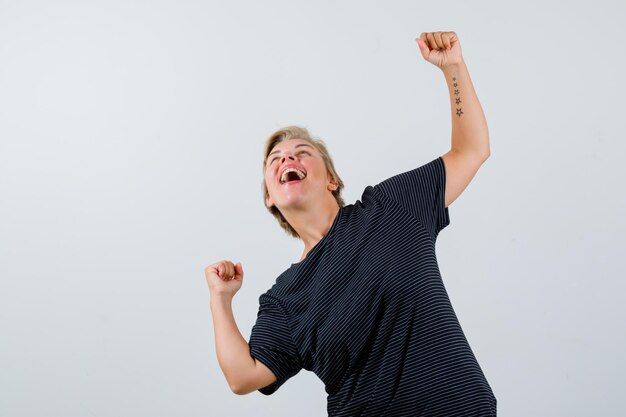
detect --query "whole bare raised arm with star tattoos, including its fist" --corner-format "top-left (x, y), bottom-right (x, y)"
top-left (416, 32), bottom-right (491, 207)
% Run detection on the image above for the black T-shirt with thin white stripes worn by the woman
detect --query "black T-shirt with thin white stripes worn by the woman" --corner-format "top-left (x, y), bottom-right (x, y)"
top-left (249, 157), bottom-right (497, 417)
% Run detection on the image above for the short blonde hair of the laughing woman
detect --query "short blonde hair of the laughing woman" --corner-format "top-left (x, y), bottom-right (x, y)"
top-left (262, 126), bottom-right (346, 238)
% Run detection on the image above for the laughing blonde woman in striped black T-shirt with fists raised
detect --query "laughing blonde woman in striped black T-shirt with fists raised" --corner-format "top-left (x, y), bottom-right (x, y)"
top-left (205, 32), bottom-right (497, 417)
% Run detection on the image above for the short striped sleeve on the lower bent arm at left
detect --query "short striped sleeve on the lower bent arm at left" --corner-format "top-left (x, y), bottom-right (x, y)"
top-left (248, 294), bottom-right (303, 395)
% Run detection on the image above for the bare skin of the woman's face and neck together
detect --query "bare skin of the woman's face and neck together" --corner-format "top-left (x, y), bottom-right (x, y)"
top-left (265, 138), bottom-right (339, 260)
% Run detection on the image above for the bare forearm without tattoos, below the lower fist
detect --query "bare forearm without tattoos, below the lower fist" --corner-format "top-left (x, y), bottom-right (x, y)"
top-left (211, 295), bottom-right (256, 391)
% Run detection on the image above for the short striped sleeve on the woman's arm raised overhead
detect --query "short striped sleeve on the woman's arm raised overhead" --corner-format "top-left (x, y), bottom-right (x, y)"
top-left (374, 156), bottom-right (450, 241)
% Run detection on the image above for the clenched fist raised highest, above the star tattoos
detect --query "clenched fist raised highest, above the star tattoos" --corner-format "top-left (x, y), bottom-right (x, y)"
top-left (415, 32), bottom-right (463, 70)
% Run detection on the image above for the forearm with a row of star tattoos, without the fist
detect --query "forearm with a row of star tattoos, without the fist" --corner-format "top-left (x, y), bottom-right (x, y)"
top-left (442, 61), bottom-right (490, 157)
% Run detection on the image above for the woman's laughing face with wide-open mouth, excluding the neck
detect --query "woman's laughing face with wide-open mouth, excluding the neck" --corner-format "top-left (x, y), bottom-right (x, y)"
top-left (265, 139), bottom-right (331, 209)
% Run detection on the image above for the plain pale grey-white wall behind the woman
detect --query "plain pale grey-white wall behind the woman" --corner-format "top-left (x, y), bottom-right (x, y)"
top-left (0, 0), bottom-right (626, 417)
